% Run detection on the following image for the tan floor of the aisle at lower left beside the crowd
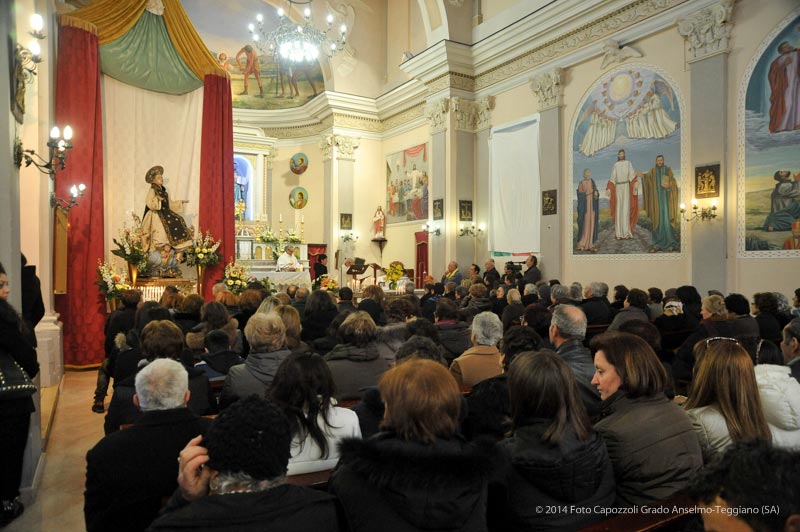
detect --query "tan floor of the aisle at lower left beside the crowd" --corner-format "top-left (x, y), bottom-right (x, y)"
top-left (4, 371), bottom-right (103, 532)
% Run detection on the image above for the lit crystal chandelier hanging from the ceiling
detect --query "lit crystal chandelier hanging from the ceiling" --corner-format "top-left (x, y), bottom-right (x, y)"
top-left (247, 0), bottom-right (347, 63)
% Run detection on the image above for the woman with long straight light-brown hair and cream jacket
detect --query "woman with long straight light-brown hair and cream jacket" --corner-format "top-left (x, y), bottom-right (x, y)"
top-left (685, 337), bottom-right (772, 463)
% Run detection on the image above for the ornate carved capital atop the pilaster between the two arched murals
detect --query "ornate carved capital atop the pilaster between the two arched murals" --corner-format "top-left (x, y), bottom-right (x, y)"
top-left (678, 0), bottom-right (735, 62)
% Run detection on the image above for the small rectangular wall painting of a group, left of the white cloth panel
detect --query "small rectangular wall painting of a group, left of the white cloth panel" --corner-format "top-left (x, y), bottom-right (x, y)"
top-left (386, 144), bottom-right (429, 224)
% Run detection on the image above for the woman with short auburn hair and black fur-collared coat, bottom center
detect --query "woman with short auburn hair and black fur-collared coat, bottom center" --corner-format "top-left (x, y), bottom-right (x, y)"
top-left (330, 357), bottom-right (494, 532)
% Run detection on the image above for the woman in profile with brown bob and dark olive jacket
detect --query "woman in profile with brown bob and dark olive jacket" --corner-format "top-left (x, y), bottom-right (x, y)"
top-left (591, 332), bottom-right (703, 506)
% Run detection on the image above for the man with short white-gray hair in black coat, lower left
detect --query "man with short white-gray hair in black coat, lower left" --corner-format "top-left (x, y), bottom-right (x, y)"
top-left (83, 358), bottom-right (211, 532)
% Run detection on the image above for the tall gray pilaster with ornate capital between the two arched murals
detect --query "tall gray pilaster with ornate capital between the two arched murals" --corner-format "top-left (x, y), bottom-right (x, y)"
top-left (678, 0), bottom-right (735, 294)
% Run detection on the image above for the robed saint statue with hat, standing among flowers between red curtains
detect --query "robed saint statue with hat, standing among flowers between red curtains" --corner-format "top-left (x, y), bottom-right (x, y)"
top-left (142, 166), bottom-right (192, 262)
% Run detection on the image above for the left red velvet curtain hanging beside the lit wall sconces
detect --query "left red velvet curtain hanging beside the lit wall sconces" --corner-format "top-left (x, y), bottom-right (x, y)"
top-left (55, 26), bottom-right (106, 366)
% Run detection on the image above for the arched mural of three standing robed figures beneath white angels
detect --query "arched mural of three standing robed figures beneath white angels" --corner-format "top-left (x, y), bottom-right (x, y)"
top-left (571, 65), bottom-right (682, 256)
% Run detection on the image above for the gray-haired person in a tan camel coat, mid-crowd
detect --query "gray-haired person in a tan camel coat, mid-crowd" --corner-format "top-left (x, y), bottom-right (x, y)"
top-left (450, 312), bottom-right (503, 388)
